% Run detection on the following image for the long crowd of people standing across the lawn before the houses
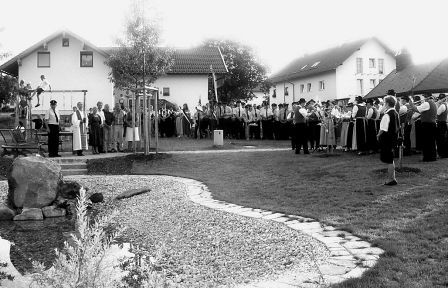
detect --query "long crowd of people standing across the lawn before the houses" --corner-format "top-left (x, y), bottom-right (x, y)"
top-left (41, 90), bottom-right (448, 171)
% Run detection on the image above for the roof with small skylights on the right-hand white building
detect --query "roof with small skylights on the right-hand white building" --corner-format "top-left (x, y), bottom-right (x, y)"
top-left (270, 38), bottom-right (394, 82)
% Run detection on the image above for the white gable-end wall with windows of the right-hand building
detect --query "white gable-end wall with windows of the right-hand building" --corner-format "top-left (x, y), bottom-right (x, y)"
top-left (336, 40), bottom-right (395, 99)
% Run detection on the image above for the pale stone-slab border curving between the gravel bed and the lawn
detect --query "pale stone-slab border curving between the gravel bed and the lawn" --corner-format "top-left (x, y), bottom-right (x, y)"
top-left (172, 177), bottom-right (384, 288)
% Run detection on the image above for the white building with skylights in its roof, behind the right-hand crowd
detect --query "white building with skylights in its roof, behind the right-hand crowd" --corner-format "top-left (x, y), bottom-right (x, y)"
top-left (270, 38), bottom-right (395, 104)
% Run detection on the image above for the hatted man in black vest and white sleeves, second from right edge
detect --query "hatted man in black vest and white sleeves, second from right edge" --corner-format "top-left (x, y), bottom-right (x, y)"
top-left (411, 93), bottom-right (437, 162)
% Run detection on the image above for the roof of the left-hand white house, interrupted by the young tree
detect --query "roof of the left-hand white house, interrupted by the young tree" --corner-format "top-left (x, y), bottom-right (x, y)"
top-left (0, 31), bottom-right (228, 75)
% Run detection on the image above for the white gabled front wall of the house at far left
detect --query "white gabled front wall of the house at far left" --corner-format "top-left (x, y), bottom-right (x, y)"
top-left (19, 35), bottom-right (113, 114)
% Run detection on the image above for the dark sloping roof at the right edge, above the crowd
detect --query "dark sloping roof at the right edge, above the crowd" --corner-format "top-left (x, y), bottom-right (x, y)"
top-left (364, 58), bottom-right (448, 99)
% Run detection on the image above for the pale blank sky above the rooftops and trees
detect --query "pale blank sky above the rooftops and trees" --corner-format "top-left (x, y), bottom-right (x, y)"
top-left (0, 0), bottom-right (448, 73)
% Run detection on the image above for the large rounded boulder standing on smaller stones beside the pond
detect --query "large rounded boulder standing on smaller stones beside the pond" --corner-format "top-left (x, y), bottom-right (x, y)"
top-left (8, 156), bottom-right (62, 208)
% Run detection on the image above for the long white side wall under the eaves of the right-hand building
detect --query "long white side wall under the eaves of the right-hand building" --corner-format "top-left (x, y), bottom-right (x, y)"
top-left (270, 71), bottom-right (336, 105)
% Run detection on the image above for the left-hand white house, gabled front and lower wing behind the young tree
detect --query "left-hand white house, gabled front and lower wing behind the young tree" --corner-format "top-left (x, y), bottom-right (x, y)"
top-left (0, 31), bottom-right (228, 114)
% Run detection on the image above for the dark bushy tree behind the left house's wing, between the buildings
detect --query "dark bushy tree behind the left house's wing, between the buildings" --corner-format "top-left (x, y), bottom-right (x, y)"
top-left (204, 40), bottom-right (267, 101)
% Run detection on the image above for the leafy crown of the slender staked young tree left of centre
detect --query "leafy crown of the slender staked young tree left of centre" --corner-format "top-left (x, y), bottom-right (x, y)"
top-left (106, 1), bottom-right (172, 89)
